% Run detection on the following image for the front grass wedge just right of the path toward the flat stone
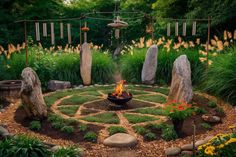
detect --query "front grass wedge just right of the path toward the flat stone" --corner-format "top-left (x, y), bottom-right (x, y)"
top-left (124, 113), bottom-right (159, 124)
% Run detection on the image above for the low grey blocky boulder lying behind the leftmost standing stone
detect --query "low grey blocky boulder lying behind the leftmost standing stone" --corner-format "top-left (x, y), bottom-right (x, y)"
top-left (48, 80), bottom-right (71, 91)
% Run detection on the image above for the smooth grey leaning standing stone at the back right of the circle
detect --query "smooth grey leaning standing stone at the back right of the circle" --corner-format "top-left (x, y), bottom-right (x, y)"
top-left (141, 45), bottom-right (158, 84)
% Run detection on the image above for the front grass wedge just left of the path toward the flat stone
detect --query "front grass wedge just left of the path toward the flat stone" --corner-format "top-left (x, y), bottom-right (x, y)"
top-left (81, 112), bottom-right (120, 124)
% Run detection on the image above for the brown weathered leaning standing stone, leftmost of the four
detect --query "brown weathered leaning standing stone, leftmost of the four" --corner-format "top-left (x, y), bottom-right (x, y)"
top-left (21, 67), bottom-right (47, 119)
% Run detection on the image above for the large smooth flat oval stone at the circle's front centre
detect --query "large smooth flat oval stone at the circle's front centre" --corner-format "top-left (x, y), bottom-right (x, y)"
top-left (103, 133), bottom-right (137, 147)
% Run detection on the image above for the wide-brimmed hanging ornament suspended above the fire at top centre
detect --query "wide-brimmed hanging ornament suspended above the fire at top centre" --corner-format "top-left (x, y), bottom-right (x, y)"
top-left (107, 16), bottom-right (128, 39)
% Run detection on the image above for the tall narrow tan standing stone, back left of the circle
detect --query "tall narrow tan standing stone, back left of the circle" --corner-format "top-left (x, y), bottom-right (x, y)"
top-left (80, 42), bottom-right (92, 86)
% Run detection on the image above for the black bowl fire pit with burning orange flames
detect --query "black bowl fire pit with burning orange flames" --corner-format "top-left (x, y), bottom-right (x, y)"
top-left (107, 80), bottom-right (133, 107)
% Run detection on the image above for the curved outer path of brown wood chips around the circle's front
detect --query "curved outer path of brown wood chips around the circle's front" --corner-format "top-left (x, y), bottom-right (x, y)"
top-left (0, 96), bottom-right (236, 157)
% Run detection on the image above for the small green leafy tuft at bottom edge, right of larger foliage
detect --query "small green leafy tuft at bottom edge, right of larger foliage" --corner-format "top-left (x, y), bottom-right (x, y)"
top-left (52, 146), bottom-right (78, 157)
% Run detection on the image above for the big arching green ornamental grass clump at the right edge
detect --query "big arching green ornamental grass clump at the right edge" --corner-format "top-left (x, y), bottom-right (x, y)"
top-left (203, 49), bottom-right (236, 105)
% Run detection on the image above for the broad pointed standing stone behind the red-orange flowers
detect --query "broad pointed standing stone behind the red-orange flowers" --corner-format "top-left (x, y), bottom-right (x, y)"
top-left (167, 55), bottom-right (193, 103)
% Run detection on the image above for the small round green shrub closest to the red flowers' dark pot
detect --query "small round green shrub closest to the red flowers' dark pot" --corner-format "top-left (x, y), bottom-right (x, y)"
top-left (161, 125), bottom-right (178, 141)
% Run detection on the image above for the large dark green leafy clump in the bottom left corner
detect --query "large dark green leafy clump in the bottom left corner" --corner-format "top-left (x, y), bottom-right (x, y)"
top-left (0, 135), bottom-right (50, 157)
